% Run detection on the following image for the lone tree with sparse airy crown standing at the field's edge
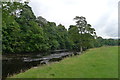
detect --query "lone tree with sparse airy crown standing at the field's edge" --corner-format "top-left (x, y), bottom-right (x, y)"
top-left (74, 16), bottom-right (96, 52)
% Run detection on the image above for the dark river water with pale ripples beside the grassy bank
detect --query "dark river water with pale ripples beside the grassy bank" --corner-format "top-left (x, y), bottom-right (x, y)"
top-left (2, 52), bottom-right (78, 78)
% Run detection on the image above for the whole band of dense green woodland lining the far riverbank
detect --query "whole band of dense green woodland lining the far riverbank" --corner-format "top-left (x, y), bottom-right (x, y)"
top-left (2, 2), bottom-right (120, 54)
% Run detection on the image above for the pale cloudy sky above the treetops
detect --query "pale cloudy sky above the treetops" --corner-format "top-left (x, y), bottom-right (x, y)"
top-left (29, 0), bottom-right (120, 38)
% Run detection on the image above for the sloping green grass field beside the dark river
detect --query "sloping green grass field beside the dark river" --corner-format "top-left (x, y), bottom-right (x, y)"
top-left (12, 47), bottom-right (118, 78)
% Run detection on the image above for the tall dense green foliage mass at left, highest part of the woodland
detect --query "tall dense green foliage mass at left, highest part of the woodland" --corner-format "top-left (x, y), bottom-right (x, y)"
top-left (2, 3), bottom-right (49, 53)
